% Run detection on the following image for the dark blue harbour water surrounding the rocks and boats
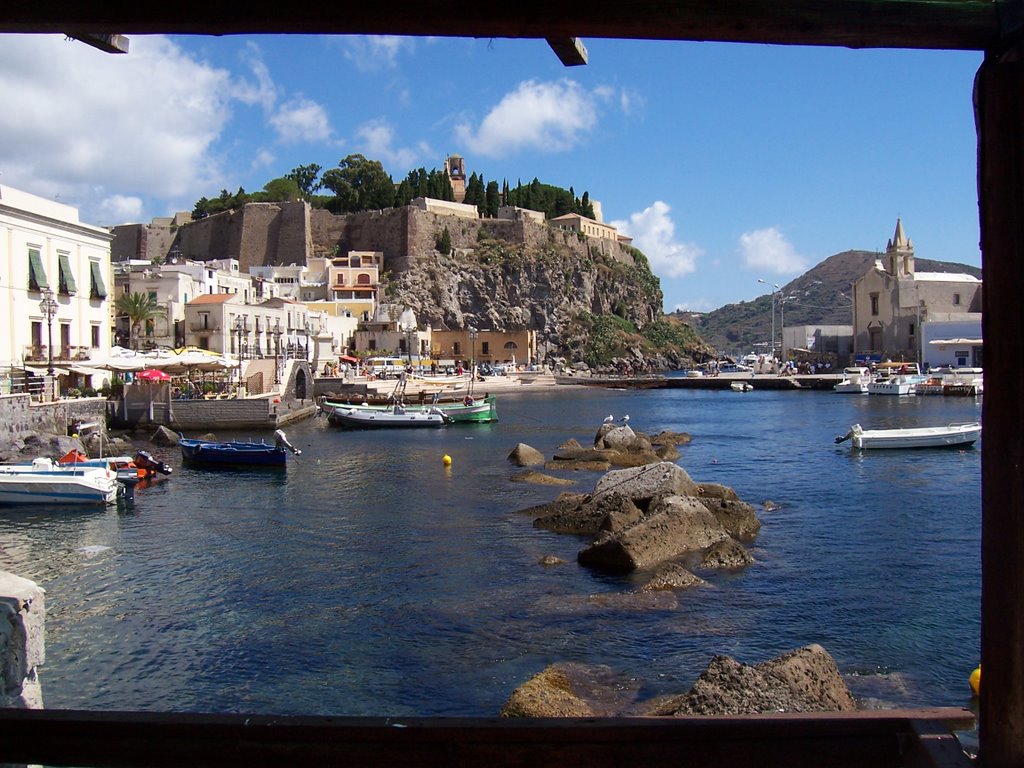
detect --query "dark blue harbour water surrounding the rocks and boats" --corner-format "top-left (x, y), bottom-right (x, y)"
top-left (0, 387), bottom-right (981, 716)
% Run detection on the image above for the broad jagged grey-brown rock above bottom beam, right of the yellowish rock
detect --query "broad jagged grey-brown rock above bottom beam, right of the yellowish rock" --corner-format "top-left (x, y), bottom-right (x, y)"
top-left (646, 644), bottom-right (857, 717)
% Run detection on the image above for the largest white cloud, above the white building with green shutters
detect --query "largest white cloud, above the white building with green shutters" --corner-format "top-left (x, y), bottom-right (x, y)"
top-left (0, 35), bottom-right (232, 223)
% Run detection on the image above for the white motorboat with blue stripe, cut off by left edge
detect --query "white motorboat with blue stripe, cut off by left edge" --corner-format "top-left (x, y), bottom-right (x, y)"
top-left (0, 459), bottom-right (121, 505)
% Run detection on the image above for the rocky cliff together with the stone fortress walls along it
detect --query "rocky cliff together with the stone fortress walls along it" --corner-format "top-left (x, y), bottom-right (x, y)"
top-left (180, 203), bottom-right (692, 366)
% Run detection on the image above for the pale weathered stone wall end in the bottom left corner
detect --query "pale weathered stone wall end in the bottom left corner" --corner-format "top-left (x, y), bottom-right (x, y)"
top-left (0, 571), bottom-right (46, 710)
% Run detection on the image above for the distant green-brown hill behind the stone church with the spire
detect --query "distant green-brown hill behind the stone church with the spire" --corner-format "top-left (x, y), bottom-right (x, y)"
top-left (674, 251), bottom-right (981, 354)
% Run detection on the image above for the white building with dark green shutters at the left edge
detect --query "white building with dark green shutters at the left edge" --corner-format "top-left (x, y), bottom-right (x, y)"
top-left (0, 185), bottom-right (113, 387)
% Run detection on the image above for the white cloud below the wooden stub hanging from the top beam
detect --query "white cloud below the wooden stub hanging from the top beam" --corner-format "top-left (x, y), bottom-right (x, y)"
top-left (456, 80), bottom-right (609, 157)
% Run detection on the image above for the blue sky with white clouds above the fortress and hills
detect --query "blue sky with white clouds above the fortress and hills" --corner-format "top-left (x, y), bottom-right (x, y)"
top-left (0, 30), bottom-right (982, 312)
